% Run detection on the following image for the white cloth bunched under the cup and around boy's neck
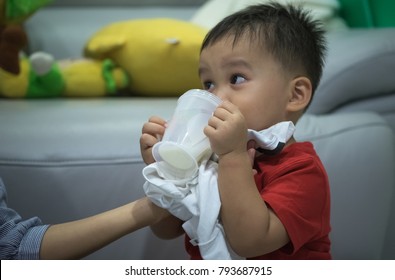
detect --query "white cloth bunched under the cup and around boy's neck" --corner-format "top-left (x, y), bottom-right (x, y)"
top-left (143, 122), bottom-right (295, 260)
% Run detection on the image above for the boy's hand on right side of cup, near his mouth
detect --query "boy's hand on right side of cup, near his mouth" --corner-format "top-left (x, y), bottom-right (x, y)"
top-left (204, 101), bottom-right (247, 157)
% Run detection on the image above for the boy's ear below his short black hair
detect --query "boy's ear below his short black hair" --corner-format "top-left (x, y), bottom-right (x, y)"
top-left (287, 76), bottom-right (313, 112)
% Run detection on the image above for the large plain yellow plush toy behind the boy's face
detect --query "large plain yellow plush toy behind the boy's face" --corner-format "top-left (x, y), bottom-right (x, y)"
top-left (84, 18), bottom-right (207, 96)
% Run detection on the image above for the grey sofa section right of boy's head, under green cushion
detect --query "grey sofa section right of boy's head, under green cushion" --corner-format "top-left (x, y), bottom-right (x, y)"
top-left (309, 28), bottom-right (395, 114)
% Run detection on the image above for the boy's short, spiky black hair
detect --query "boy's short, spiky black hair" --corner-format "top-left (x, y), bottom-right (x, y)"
top-left (201, 3), bottom-right (326, 96)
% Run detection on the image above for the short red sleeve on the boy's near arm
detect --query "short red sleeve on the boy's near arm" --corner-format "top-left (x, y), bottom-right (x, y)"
top-left (262, 154), bottom-right (330, 252)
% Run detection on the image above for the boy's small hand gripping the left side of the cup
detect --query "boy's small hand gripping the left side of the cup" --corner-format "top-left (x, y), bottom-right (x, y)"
top-left (140, 116), bottom-right (166, 164)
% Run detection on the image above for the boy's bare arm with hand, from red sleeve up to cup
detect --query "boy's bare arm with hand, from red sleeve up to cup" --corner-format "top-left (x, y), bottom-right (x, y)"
top-left (205, 101), bottom-right (289, 257)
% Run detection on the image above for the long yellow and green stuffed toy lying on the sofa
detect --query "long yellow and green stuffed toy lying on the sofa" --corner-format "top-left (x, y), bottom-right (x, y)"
top-left (0, 52), bottom-right (129, 98)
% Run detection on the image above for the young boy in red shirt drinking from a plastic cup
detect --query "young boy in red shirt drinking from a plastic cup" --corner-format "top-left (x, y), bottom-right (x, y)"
top-left (140, 3), bottom-right (331, 259)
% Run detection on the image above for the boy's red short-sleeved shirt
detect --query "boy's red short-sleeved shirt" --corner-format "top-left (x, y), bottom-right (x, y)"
top-left (185, 142), bottom-right (331, 260)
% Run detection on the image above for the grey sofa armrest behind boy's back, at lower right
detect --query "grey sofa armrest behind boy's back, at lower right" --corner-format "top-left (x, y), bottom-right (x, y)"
top-left (295, 112), bottom-right (395, 259)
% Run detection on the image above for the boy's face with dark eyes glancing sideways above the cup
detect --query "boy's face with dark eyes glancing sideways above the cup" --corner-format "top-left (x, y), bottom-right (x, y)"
top-left (199, 37), bottom-right (292, 131)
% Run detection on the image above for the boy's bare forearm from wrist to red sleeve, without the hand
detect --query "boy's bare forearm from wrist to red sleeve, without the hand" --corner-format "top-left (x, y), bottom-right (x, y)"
top-left (218, 152), bottom-right (289, 257)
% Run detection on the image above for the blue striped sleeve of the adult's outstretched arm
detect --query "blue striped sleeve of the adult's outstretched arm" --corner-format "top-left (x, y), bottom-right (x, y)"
top-left (0, 178), bottom-right (49, 260)
